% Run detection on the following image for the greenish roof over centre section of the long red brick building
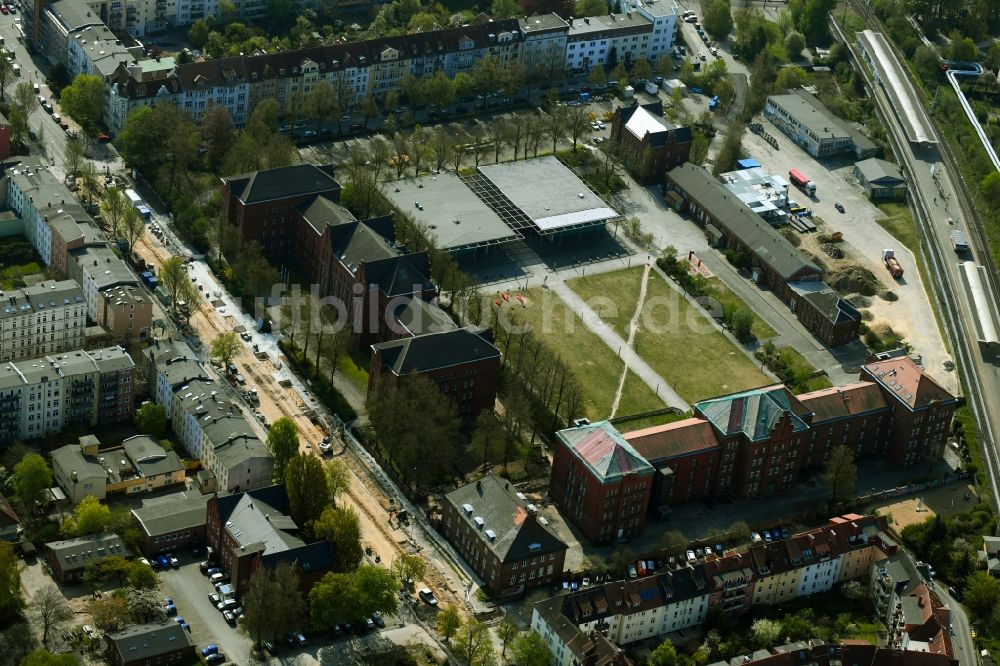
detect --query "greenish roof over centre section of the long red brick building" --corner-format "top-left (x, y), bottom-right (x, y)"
top-left (694, 384), bottom-right (809, 442)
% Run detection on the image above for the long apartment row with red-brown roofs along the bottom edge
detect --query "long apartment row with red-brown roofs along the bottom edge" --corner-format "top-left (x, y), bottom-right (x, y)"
top-left (531, 514), bottom-right (900, 666)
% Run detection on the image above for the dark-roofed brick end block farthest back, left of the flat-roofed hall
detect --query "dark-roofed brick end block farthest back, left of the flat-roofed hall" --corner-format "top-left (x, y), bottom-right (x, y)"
top-left (221, 164), bottom-right (341, 258)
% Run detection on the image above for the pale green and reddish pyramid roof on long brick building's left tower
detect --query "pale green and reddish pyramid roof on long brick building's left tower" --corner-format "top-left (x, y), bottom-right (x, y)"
top-left (557, 421), bottom-right (654, 483)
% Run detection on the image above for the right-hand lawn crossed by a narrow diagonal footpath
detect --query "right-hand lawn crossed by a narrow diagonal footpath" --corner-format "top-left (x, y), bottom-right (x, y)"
top-left (568, 267), bottom-right (768, 402)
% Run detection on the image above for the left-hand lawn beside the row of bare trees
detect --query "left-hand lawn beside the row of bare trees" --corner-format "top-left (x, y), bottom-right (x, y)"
top-left (507, 288), bottom-right (664, 420)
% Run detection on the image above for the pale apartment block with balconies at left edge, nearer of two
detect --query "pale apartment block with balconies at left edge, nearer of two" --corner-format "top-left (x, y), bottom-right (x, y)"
top-left (0, 347), bottom-right (135, 443)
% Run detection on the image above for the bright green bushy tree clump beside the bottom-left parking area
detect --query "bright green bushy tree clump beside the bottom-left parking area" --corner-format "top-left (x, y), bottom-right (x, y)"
top-left (309, 564), bottom-right (399, 630)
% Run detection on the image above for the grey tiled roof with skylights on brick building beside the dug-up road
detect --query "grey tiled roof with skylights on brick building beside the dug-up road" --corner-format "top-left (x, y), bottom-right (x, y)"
top-left (445, 475), bottom-right (567, 562)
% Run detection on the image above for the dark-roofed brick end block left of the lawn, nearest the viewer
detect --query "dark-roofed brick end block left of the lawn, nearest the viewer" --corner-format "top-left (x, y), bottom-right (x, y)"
top-left (368, 328), bottom-right (501, 420)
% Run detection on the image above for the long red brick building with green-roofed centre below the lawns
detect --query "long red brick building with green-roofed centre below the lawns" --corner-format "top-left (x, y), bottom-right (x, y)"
top-left (550, 357), bottom-right (958, 541)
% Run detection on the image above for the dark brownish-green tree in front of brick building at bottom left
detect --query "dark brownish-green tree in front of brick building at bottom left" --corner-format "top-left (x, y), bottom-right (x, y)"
top-left (243, 562), bottom-right (306, 644)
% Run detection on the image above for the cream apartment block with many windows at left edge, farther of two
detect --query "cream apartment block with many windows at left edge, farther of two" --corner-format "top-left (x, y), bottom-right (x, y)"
top-left (0, 280), bottom-right (87, 361)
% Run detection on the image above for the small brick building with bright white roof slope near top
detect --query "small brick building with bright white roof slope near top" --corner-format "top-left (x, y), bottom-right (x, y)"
top-left (611, 102), bottom-right (692, 183)
